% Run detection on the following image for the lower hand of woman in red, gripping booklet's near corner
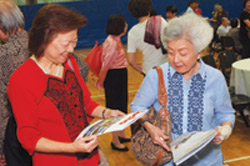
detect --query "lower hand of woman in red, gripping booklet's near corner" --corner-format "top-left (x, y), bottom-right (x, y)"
top-left (72, 136), bottom-right (98, 153)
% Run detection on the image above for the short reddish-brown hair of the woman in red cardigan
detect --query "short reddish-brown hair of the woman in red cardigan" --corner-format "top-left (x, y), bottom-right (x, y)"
top-left (29, 4), bottom-right (87, 58)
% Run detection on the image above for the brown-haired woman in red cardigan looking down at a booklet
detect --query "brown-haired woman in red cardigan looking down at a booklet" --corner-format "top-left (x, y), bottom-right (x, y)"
top-left (8, 4), bottom-right (123, 166)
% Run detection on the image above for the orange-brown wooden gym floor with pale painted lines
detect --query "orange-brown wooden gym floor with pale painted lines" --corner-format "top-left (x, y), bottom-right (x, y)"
top-left (75, 46), bottom-right (250, 166)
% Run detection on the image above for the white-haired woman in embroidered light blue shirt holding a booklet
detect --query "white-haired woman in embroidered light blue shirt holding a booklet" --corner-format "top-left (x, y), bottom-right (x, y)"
top-left (131, 13), bottom-right (235, 166)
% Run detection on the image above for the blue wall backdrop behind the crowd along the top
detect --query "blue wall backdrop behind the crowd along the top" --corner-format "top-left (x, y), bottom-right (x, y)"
top-left (20, 0), bottom-right (243, 49)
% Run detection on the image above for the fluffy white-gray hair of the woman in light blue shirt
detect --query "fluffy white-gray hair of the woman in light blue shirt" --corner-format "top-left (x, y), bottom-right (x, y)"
top-left (162, 13), bottom-right (213, 53)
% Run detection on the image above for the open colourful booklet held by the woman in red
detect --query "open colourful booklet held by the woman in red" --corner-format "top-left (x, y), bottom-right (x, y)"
top-left (76, 110), bottom-right (148, 139)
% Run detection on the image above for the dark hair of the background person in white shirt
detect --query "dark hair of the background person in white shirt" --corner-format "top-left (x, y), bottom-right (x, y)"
top-left (128, 0), bottom-right (152, 18)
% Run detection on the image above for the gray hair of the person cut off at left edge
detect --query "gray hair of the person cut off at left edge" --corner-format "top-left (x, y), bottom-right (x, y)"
top-left (0, 0), bottom-right (24, 34)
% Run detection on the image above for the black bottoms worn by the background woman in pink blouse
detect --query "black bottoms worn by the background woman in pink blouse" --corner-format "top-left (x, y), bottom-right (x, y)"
top-left (104, 68), bottom-right (128, 113)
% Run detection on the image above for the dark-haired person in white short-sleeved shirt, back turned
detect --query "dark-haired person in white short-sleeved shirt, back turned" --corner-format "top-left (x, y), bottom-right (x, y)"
top-left (127, 0), bottom-right (167, 75)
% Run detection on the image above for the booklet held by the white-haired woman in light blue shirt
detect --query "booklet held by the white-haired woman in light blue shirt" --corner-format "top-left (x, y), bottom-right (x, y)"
top-left (170, 130), bottom-right (216, 165)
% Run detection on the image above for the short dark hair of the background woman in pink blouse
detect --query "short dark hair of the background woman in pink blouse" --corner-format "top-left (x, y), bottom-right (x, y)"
top-left (106, 14), bottom-right (126, 36)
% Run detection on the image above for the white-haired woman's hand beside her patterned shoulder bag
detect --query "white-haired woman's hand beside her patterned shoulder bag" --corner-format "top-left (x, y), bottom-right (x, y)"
top-left (144, 122), bottom-right (171, 151)
